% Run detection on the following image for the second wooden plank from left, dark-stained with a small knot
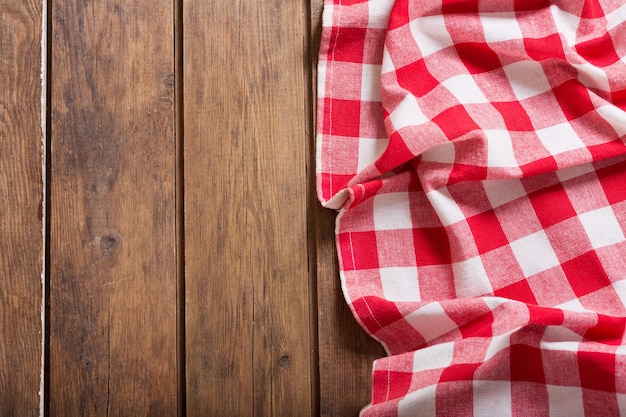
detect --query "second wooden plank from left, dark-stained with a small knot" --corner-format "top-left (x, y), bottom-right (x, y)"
top-left (49, 0), bottom-right (177, 416)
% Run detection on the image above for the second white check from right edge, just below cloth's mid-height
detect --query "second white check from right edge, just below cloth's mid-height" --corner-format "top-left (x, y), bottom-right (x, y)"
top-left (511, 230), bottom-right (559, 277)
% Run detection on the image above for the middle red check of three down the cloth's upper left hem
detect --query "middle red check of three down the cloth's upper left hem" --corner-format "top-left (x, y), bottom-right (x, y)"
top-left (322, 98), bottom-right (361, 138)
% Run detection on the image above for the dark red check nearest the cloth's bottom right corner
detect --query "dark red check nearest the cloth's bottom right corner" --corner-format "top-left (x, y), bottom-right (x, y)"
top-left (578, 352), bottom-right (616, 392)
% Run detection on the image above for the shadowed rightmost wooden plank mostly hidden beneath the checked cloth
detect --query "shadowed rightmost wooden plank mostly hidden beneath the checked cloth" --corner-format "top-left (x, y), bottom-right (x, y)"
top-left (311, 0), bottom-right (385, 417)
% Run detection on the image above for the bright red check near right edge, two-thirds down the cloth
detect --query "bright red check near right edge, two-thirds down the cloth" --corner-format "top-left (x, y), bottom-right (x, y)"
top-left (561, 251), bottom-right (611, 297)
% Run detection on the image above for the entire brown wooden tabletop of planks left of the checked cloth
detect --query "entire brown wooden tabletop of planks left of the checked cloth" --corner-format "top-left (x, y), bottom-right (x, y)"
top-left (0, 0), bottom-right (383, 417)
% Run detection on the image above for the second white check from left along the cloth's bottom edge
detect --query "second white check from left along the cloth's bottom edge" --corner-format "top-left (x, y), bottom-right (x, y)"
top-left (472, 381), bottom-right (513, 417)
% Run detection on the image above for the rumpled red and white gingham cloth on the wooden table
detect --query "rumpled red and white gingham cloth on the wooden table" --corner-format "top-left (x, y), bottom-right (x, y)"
top-left (316, 0), bottom-right (626, 417)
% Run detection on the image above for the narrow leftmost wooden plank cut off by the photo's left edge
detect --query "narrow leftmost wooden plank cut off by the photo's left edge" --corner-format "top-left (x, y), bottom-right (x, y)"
top-left (0, 0), bottom-right (44, 416)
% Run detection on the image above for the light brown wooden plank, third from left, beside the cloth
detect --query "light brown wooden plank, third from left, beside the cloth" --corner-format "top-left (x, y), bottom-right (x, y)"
top-left (184, 0), bottom-right (315, 417)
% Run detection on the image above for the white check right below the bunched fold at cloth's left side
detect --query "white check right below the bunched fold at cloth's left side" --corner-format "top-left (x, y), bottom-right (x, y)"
top-left (374, 193), bottom-right (413, 230)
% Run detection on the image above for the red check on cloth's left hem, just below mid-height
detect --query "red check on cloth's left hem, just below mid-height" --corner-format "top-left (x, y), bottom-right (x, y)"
top-left (337, 232), bottom-right (379, 271)
